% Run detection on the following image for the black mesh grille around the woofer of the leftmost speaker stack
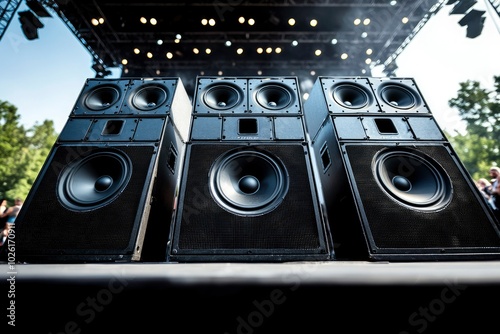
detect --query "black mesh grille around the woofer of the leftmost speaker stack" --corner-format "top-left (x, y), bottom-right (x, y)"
top-left (16, 146), bottom-right (154, 255)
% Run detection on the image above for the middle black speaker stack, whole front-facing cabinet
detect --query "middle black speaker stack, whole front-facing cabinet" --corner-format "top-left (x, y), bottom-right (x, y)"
top-left (168, 77), bottom-right (333, 262)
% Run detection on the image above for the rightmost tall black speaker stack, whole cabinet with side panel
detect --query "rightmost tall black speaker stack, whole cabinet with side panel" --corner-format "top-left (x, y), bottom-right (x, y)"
top-left (304, 77), bottom-right (500, 261)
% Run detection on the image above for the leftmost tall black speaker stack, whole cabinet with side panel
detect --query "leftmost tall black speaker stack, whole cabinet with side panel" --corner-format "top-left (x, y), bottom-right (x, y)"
top-left (16, 78), bottom-right (191, 262)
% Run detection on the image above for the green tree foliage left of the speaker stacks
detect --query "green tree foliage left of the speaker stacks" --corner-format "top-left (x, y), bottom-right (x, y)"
top-left (0, 101), bottom-right (57, 203)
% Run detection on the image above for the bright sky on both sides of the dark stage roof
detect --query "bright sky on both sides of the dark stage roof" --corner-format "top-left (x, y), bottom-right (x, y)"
top-left (0, 0), bottom-right (500, 134)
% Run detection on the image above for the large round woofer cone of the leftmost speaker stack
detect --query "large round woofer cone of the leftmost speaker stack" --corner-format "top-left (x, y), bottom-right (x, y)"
top-left (57, 151), bottom-right (132, 211)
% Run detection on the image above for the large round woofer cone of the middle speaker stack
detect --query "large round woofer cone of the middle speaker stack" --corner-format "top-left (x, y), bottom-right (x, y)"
top-left (210, 149), bottom-right (288, 216)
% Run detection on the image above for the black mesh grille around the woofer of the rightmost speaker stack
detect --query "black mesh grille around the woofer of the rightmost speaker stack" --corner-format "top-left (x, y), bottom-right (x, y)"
top-left (345, 145), bottom-right (500, 248)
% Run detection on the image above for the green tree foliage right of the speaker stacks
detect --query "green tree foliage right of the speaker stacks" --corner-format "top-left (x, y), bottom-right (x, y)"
top-left (448, 76), bottom-right (500, 179)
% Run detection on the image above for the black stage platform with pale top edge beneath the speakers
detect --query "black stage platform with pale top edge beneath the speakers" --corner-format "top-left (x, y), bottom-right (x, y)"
top-left (0, 261), bottom-right (500, 334)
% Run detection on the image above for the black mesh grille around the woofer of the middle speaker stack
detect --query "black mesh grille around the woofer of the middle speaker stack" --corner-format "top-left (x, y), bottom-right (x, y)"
top-left (178, 144), bottom-right (319, 250)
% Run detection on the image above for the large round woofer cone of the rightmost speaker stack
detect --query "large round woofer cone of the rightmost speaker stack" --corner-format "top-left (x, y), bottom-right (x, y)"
top-left (373, 149), bottom-right (452, 210)
